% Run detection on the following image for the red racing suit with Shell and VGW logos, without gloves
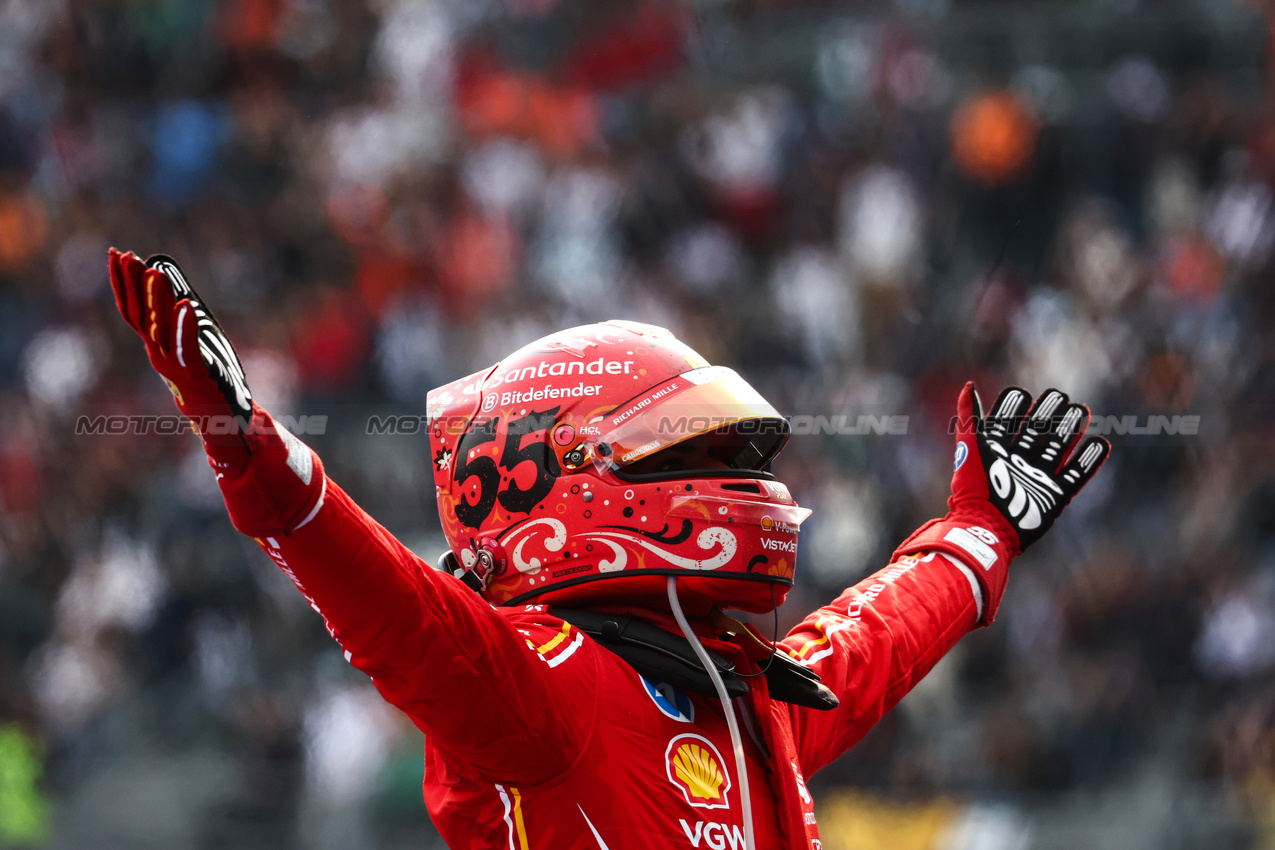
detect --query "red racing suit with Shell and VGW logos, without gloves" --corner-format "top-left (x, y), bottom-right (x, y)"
top-left (226, 420), bottom-right (1011, 850)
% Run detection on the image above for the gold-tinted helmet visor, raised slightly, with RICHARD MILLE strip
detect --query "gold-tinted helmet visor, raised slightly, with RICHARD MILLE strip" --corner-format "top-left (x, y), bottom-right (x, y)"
top-left (589, 366), bottom-right (789, 474)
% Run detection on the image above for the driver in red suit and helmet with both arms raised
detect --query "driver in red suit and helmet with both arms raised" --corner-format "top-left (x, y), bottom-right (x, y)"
top-left (110, 250), bottom-right (1109, 850)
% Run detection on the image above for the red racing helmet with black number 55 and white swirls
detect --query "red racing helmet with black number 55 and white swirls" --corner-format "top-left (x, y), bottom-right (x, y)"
top-left (427, 321), bottom-right (810, 613)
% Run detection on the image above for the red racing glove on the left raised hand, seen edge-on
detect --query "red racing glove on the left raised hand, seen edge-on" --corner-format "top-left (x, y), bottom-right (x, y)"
top-left (108, 249), bottom-right (326, 537)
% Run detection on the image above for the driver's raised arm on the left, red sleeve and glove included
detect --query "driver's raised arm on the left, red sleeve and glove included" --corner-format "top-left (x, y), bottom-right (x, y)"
top-left (110, 249), bottom-right (595, 785)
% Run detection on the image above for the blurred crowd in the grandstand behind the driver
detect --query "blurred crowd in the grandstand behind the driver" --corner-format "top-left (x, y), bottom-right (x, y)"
top-left (0, 0), bottom-right (1275, 850)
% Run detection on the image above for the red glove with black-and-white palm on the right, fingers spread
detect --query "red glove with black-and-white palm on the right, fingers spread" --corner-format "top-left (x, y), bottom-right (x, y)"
top-left (895, 381), bottom-right (1111, 626)
